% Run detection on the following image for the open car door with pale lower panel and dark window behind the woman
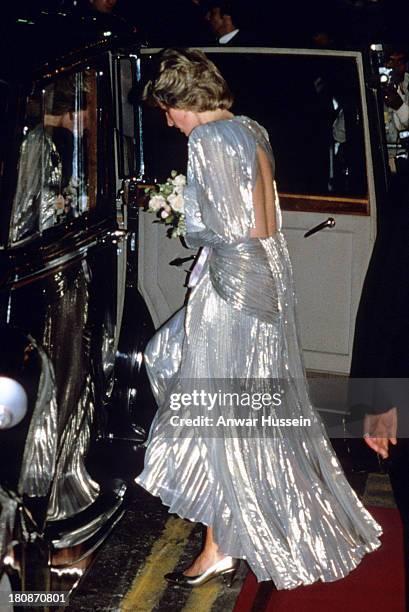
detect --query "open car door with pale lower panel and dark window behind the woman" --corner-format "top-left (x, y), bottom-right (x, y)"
top-left (139, 47), bottom-right (379, 374)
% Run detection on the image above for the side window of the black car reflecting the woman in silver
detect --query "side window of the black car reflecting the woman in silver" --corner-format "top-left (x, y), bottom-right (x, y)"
top-left (11, 70), bottom-right (97, 242)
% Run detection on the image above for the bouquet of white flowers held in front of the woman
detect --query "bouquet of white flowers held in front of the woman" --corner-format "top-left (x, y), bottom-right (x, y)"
top-left (145, 170), bottom-right (186, 238)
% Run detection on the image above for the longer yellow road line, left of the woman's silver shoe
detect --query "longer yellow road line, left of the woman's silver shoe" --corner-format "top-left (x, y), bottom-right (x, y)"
top-left (121, 517), bottom-right (195, 612)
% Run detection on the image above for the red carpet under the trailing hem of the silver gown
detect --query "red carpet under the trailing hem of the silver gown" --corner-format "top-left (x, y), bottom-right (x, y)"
top-left (234, 508), bottom-right (405, 612)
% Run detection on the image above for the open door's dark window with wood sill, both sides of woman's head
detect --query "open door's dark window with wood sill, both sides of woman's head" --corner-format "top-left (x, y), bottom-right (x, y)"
top-left (143, 48), bottom-right (368, 214)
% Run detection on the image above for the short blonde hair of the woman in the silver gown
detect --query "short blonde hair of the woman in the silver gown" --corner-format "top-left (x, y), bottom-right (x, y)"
top-left (143, 49), bottom-right (233, 112)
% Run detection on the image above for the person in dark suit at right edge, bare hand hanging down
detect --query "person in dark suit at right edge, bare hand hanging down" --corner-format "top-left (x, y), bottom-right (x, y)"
top-left (350, 97), bottom-right (409, 610)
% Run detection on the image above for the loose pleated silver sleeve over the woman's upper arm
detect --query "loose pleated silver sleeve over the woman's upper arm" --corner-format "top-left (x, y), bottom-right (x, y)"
top-left (188, 120), bottom-right (257, 243)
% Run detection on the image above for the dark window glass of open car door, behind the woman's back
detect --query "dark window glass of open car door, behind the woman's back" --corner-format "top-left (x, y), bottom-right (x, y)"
top-left (212, 53), bottom-right (367, 197)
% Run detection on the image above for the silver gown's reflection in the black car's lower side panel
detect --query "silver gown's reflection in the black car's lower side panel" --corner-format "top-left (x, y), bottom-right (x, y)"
top-left (42, 260), bottom-right (100, 521)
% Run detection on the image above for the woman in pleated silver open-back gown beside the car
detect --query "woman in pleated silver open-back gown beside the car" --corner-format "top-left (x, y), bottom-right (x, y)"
top-left (136, 49), bottom-right (381, 589)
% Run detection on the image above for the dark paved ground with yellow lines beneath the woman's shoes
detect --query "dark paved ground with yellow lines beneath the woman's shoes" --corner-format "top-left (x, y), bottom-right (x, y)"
top-left (65, 446), bottom-right (393, 612)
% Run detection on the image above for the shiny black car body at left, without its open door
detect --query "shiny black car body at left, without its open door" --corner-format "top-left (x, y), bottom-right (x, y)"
top-left (0, 10), bottom-right (154, 603)
